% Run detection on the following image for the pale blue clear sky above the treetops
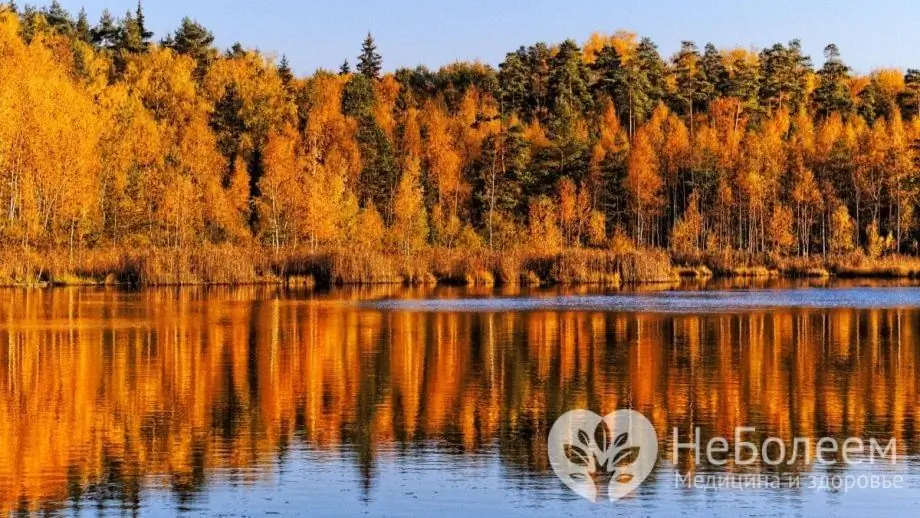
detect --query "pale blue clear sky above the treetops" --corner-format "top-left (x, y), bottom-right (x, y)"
top-left (57, 0), bottom-right (920, 74)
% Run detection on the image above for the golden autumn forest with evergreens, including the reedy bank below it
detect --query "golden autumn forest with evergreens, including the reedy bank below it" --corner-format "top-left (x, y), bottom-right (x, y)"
top-left (0, 2), bottom-right (920, 285)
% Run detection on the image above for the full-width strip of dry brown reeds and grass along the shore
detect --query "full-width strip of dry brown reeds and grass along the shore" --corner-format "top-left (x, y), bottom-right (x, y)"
top-left (7, 245), bottom-right (920, 287)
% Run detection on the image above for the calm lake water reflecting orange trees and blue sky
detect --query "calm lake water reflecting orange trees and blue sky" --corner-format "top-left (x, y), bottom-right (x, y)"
top-left (0, 283), bottom-right (920, 517)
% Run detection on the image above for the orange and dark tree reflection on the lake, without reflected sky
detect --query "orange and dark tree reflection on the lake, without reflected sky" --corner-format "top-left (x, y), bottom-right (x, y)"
top-left (0, 286), bottom-right (920, 514)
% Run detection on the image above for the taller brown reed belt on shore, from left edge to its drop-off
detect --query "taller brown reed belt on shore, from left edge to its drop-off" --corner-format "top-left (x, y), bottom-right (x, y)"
top-left (0, 246), bottom-right (677, 287)
